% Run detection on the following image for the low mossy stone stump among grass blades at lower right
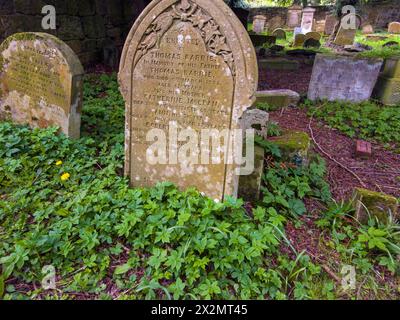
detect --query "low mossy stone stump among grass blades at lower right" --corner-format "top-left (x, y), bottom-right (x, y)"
top-left (353, 188), bottom-right (399, 224)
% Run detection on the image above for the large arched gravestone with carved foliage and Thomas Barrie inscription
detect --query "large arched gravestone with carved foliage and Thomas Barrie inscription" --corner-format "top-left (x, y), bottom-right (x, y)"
top-left (119, 0), bottom-right (258, 200)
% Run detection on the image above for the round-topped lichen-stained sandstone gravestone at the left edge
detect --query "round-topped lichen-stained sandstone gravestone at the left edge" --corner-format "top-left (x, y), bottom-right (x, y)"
top-left (0, 33), bottom-right (83, 138)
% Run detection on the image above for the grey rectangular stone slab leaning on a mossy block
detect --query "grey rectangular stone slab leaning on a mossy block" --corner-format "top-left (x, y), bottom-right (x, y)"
top-left (308, 54), bottom-right (383, 102)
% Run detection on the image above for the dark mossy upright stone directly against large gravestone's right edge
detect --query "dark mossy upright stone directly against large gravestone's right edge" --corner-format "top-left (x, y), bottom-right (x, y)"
top-left (238, 146), bottom-right (265, 203)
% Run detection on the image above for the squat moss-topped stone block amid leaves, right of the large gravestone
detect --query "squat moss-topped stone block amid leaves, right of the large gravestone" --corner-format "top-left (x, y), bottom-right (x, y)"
top-left (269, 130), bottom-right (311, 165)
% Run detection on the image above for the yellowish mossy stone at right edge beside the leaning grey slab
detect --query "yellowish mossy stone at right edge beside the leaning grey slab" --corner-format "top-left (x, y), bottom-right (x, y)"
top-left (372, 58), bottom-right (400, 106)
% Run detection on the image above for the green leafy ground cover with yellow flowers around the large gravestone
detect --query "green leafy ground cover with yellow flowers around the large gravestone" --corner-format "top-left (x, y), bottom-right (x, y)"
top-left (0, 74), bottom-right (400, 299)
